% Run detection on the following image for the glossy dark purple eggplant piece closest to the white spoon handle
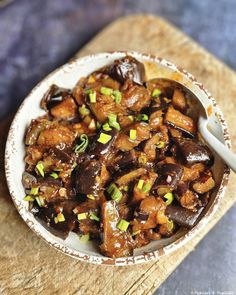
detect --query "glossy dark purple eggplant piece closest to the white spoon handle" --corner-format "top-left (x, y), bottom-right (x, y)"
top-left (176, 138), bottom-right (213, 166)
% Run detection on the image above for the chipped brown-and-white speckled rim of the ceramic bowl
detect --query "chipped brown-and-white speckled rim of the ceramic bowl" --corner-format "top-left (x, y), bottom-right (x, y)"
top-left (5, 51), bottom-right (231, 266)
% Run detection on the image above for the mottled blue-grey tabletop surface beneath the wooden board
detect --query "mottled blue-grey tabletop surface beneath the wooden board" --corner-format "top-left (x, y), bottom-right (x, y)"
top-left (0, 0), bottom-right (236, 295)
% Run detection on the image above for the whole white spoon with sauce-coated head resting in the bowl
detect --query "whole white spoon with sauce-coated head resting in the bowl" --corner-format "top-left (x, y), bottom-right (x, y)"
top-left (160, 78), bottom-right (236, 172)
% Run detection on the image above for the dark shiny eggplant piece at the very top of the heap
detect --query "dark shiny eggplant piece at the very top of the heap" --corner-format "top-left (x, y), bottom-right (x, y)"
top-left (107, 56), bottom-right (145, 85)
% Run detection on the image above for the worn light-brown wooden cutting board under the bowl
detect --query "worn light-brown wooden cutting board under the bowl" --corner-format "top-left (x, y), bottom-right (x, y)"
top-left (0, 15), bottom-right (236, 295)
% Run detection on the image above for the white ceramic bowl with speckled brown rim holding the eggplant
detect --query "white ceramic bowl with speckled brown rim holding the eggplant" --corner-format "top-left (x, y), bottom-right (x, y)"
top-left (5, 52), bottom-right (230, 265)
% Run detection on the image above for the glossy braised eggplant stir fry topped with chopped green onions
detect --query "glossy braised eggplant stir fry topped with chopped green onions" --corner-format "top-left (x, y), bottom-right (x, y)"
top-left (23, 56), bottom-right (215, 257)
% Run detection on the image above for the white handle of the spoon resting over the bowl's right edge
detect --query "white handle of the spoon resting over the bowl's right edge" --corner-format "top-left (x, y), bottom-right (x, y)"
top-left (198, 117), bottom-right (236, 172)
